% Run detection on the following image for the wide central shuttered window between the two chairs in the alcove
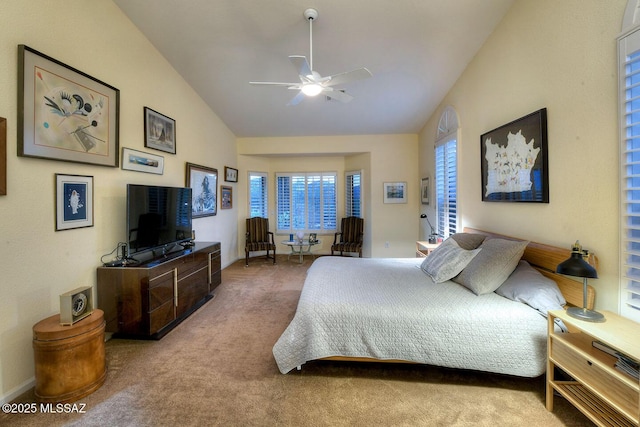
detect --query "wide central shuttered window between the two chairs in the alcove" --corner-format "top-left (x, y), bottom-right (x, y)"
top-left (276, 172), bottom-right (337, 233)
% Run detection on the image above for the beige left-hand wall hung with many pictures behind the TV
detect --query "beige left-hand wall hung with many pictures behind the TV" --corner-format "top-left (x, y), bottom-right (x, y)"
top-left (0, 0), bottom-right (237, 401)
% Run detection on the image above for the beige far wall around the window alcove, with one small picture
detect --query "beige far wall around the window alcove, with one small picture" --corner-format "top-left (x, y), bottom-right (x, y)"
top-left (237, 135), bottom-right (420, 258)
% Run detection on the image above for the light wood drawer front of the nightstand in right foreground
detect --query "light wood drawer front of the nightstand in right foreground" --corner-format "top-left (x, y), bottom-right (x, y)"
top-left (550, 338), bottom-right (640, 416)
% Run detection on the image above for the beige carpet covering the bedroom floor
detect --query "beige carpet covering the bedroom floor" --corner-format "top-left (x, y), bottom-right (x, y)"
top-left (0, 257), bottom-right (592, 426)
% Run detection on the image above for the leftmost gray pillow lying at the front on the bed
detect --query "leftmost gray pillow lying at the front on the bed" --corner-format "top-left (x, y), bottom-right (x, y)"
top-left (420, 238), bottom-right (480, 283)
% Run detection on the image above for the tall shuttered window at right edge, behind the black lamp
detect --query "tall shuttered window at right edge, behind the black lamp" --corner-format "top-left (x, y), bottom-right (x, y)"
top-left (618, 25), bottom-right (640, 321)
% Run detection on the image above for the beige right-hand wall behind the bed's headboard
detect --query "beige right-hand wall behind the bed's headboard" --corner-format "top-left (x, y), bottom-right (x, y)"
top-left (420, 0), bottom-right (626, 311)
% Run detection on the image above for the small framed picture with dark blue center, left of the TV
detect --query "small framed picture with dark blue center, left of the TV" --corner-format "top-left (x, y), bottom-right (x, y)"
top-left (56, 173), bottom-right (93, 231)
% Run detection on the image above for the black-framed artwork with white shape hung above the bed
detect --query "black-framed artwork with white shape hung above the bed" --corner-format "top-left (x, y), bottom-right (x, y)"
top-left (480, 108), bottom-right (549, 203)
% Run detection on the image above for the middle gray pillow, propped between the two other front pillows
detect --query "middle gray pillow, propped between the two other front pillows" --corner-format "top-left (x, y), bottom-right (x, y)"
top-left (453, 239), bottom-right (529, 295)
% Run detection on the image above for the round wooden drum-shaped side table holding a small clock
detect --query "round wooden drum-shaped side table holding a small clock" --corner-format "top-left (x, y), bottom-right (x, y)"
top-left (33, 309), bottom-right (107, 403)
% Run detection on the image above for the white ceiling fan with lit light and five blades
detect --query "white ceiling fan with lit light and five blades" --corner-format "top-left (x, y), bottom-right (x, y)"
top-left (249, 9), bottom-right (372, 105)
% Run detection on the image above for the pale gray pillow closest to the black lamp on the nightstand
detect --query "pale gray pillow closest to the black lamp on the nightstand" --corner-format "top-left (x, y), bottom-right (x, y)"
top-left (496, 261), bottom-right (566, 317)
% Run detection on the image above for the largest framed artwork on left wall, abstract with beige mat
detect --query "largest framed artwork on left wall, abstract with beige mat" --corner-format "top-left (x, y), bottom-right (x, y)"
top-left (18, 45), bottom-right (120, 167)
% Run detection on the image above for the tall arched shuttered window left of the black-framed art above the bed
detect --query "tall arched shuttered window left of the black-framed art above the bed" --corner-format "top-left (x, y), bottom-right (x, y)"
top-left (435, 107), bottom-right (458, 238)
